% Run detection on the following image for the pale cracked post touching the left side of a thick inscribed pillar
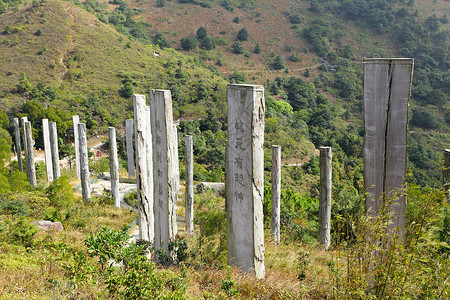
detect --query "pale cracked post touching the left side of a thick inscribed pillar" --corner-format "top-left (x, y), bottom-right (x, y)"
top-left (133, 94), bottom-right (153, 242)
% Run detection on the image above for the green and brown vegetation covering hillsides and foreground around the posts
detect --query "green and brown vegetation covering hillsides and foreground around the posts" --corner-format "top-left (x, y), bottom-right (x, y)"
top-left (0, 0), bottom-right (450, 299)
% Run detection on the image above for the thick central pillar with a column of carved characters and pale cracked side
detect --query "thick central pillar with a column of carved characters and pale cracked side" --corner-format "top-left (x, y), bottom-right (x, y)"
top-left (226, 84), bottom-right (265, 278)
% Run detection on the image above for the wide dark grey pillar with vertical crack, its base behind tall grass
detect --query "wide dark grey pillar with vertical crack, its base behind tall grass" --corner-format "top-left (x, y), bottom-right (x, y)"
top-left (364, 58), bottom-right (414, 240)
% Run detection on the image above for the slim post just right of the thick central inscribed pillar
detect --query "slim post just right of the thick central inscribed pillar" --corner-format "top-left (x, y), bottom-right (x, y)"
top-left (270, 145), bottom-right (281, 243)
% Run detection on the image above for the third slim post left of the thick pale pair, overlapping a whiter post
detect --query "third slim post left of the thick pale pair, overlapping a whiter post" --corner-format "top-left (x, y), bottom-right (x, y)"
top-left (77, 123), bottom-right (91, 202)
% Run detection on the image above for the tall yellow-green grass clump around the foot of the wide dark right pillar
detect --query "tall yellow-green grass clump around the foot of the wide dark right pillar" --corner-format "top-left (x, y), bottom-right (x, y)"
top-left (327, 186), bottom-right (450, 299)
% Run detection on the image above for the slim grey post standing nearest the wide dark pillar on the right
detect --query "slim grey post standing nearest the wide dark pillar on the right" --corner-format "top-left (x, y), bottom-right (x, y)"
top-left (319, 147), bottom-right (332, 250)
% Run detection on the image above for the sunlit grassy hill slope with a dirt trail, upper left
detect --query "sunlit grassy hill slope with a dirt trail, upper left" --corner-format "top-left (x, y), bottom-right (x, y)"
top-left (0, 1), bottom-right (225, 125)
